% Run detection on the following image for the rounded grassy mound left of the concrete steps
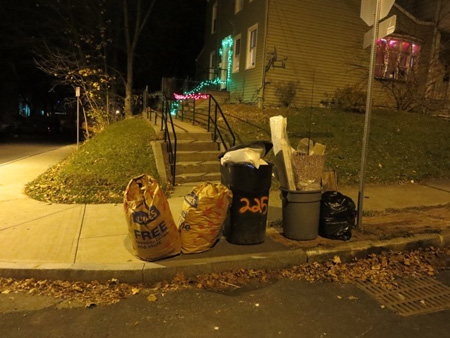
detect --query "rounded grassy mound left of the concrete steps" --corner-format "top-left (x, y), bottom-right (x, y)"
top-left (25, 119), bottom-right (158, 203)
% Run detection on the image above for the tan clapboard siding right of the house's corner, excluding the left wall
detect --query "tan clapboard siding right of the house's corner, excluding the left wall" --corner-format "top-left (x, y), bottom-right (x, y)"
top-left (264, 0), bottom-right (436, 106)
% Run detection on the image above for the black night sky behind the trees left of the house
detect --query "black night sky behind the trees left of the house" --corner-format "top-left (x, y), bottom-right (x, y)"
top-left (0, 0), bottom-right (206, 116)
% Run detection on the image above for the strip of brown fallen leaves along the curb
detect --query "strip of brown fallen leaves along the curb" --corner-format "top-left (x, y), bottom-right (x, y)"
top-left (0, 247), bottom-right (450, 308)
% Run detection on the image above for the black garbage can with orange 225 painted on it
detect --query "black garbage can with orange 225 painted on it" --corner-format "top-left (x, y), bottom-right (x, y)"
top-left (220, 163), bottom-right (272, 244)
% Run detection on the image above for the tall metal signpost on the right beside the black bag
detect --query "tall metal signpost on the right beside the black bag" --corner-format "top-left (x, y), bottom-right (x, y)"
top-left (357, 0), bottom-right (381, 230)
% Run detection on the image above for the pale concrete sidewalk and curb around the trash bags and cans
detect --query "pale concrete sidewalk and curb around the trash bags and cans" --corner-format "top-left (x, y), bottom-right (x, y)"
top-left (0, 146), bottom-right (450, 282)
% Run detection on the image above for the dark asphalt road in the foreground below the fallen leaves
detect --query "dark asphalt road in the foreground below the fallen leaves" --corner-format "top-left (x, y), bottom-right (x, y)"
top-left (0, 272), bottom-right (450, 338)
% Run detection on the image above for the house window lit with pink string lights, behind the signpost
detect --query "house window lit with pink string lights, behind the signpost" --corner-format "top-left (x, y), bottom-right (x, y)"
top-left (375, 38), bottom-right (420, 80)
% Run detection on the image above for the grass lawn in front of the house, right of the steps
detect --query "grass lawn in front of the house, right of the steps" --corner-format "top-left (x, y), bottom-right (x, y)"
top-left (222, 105), bottom-right (450, 184)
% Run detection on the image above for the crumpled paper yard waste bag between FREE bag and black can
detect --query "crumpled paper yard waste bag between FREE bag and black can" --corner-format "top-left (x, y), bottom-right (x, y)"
top-left (179, 182), bottom-right (233, 253)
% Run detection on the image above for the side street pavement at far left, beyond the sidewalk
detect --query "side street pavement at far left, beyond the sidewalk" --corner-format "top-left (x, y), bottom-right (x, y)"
top-left (0, 141), bottom-right (71, 165)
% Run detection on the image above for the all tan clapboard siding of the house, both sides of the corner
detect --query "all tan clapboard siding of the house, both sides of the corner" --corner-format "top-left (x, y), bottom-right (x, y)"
top-left (197, 0), bottom-right (433, 106)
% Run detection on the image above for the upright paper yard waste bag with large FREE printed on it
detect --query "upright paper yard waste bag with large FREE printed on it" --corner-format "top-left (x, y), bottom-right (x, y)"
top-left (124, 175), bottom-right (181, 261)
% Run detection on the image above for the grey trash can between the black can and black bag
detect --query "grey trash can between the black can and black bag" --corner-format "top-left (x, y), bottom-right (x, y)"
top-left (280, 187), bottom-right (322, 241)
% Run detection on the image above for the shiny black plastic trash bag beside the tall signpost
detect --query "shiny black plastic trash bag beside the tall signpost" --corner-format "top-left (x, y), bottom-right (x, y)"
top-left (319, 191), bottom-right (356, 241)
